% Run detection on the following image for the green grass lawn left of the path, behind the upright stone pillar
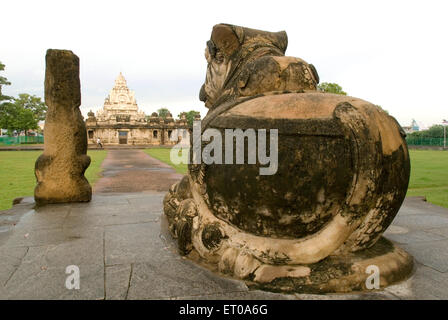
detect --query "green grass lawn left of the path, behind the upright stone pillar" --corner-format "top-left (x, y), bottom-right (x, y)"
top-left (0, 150), bottom-right (107, 210)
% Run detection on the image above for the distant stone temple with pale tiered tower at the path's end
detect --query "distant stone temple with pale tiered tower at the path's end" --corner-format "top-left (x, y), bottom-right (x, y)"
top-left (86, 72), bottom-right (194, 145)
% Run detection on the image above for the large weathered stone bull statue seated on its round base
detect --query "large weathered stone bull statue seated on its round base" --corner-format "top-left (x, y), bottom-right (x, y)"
top-left (164, 24), bottom-right (413, 292)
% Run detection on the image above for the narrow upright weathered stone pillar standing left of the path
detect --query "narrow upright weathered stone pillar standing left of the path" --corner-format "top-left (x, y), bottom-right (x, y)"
top-left (34, 49), bottom-right (92, 205)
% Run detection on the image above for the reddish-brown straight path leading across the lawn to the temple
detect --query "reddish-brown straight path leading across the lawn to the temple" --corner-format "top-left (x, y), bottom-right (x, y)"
top-left (94, 149), bottom-right (182, 193)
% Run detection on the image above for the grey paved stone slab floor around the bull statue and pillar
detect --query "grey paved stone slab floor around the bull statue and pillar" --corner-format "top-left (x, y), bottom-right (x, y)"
top-left (0, 151), bottom-right (448, 299)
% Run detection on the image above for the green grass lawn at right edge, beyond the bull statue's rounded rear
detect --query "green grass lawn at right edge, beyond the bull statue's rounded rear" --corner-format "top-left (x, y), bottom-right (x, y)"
top-left (407, 150), bottom-right (448, 208)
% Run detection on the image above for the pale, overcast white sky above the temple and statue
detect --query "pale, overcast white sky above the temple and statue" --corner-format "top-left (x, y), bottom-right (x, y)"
top-left (0, 0), bottom-right (448, 128)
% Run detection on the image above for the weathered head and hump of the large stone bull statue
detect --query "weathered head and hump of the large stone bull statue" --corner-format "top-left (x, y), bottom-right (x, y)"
top-left (199, 24), bottom-right (319, 109)
